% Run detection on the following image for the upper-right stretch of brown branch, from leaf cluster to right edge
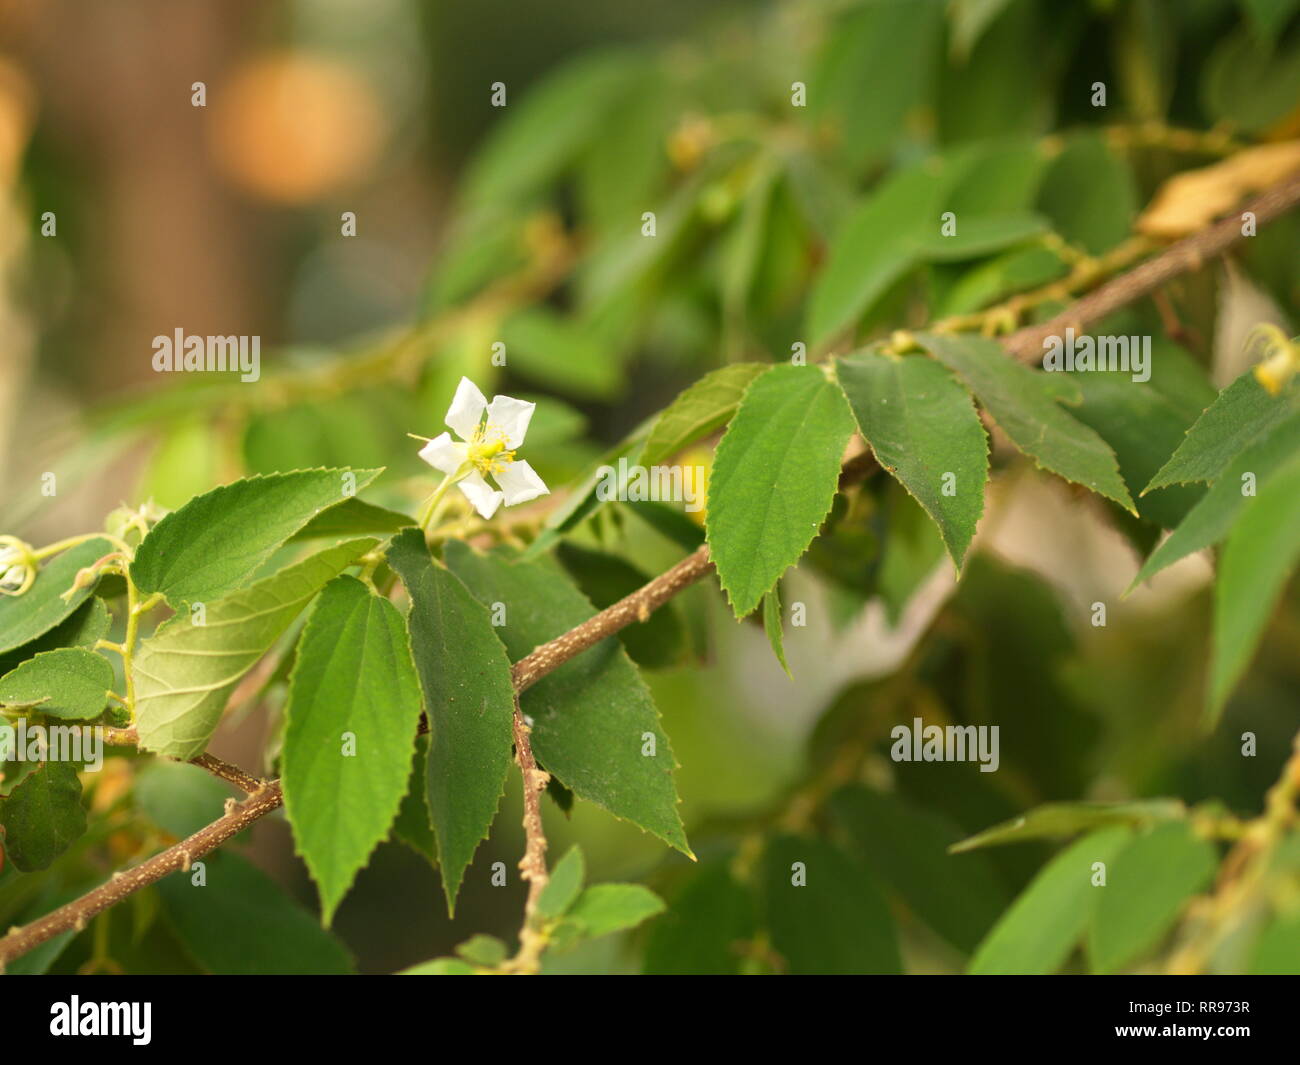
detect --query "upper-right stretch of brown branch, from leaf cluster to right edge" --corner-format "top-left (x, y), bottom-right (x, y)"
top-left (1002, 173), bottom-right (1300, 362)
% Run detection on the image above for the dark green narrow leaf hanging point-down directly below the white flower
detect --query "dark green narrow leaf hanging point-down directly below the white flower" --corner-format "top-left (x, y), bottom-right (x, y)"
top-left (387, 529), bottom-right (515, 913)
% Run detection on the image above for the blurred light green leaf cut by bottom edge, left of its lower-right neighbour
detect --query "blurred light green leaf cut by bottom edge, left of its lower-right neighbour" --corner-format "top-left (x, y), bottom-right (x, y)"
top-left (966, 827), bottom-right (1132, 977)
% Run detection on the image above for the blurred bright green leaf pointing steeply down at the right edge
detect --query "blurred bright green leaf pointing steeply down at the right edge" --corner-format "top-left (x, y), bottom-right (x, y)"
top-left (1208, 455), bottom-right (1300, 720)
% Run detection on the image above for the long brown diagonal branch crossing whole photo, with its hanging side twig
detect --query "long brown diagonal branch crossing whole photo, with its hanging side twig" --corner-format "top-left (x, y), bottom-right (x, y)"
top-left (0, 166), bottom-right (1300, 969)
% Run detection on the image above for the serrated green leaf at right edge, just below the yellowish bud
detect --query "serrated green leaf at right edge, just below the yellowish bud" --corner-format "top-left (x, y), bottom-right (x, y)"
top-left (1143, 369), bottom-right (1296, 494)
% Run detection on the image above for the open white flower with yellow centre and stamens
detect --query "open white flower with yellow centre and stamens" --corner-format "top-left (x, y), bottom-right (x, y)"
top-left (420, 377), bottom-right (550, 518)
